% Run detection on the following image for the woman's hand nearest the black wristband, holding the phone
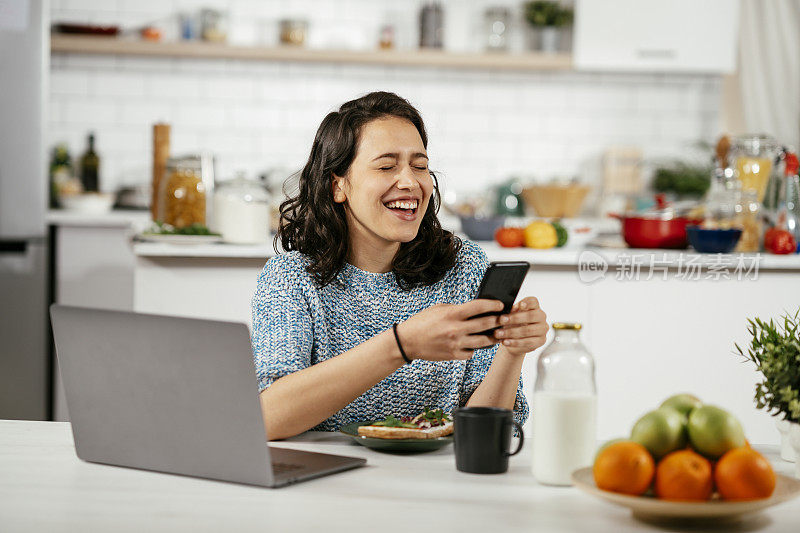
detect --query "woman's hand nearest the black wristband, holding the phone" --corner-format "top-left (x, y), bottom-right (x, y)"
top-left (397, 299), bottom-right (503, 361)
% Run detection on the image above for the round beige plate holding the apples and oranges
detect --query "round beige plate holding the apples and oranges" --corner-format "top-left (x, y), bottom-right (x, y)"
top-left (572, 468), bottom-right (800, 521)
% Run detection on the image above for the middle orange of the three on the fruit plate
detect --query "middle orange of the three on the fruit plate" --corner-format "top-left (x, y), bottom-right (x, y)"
top-left (655, 450), bottom-right (714, 500)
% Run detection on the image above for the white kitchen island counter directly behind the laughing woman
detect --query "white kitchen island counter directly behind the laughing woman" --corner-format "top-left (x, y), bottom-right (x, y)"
top-left (134, 243), bottom-right (800, 444)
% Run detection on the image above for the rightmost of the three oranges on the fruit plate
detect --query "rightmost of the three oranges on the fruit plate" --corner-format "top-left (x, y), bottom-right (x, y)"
top-left (714, 447), bottom-right (775, 500)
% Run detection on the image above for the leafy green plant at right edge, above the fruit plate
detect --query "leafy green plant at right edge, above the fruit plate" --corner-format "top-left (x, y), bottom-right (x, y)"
top-left (735, 309), bottom-right (800, 422)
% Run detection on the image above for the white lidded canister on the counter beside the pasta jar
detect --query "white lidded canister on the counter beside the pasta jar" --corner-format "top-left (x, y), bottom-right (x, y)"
top-left (214, 172), bottom-right (271, 244)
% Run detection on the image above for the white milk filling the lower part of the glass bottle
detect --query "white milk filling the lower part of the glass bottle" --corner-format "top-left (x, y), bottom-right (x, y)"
top-left (531, 392), bottom-right (597, 485)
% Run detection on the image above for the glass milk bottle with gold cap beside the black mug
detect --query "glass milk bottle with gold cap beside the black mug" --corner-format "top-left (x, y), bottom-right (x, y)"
top-left (532, 322), bottom-right (597, 485)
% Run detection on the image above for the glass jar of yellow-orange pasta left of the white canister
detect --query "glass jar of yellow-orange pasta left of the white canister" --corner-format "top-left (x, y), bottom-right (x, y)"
top-left (157, 158), bottom-right (206, 228)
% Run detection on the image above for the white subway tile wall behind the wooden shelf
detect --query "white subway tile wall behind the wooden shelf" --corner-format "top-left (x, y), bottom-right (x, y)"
top-left (48, 0), bottom-right (721, 196)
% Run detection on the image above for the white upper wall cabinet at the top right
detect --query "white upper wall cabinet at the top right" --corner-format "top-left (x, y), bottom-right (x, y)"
top-left (573, 0), bottom-right (739, 74)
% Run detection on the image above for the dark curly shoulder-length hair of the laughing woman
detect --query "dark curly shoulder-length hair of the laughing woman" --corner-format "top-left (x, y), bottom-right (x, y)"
top-left (274, 92), bottom-right (461, 291)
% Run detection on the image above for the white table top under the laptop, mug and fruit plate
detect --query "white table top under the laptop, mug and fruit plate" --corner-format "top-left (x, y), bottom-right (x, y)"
top-left (0, 421), bottom-right (800, 533)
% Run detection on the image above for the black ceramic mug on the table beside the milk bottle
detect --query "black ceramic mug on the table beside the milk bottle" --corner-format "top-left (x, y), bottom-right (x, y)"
top-left (454, 407), bottom-right (525, 474)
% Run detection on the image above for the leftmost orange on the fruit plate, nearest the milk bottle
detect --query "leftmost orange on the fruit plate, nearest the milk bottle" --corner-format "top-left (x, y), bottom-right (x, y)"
top-left (592, 441), bottom-right (656, 495)
